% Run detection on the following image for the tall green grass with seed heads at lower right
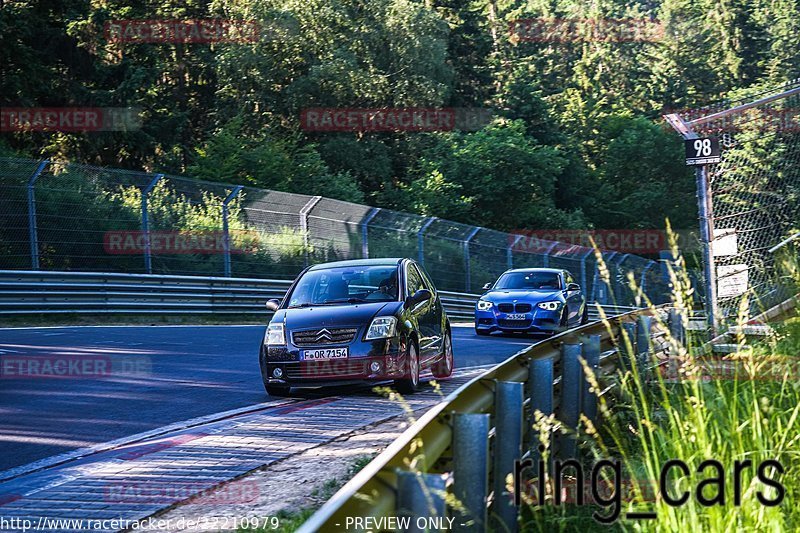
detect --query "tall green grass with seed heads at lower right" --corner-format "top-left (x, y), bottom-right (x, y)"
top-left (522, 231), bottom-right (800, 532)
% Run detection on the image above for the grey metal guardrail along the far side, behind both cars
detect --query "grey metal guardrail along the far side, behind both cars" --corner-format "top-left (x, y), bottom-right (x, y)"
top-left (0, 270), bottom-right (631, 319)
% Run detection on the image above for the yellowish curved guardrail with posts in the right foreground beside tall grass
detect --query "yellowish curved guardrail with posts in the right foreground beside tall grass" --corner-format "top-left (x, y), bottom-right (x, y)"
top-left (299, 308), bottom-right (685, 533)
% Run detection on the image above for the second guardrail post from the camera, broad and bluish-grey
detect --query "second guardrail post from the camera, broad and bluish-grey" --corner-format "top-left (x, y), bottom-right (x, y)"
top-left (453, 413), bottom-right (489, 533)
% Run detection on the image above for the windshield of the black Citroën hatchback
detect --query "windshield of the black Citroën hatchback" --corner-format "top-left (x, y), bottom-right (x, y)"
top-left (289, 265), bottom-right (397, 307)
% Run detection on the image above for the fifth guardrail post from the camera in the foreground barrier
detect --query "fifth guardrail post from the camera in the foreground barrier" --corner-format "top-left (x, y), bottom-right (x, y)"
top-left (558, 344), bottom-right (583, 459)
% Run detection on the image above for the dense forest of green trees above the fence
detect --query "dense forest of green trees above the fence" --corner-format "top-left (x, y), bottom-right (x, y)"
top-left (0, 0), bottom-right (800, 230)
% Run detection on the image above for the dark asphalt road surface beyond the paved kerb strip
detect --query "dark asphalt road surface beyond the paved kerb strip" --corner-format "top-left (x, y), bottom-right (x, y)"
top-left (0, 326), bottom-right (537, 471)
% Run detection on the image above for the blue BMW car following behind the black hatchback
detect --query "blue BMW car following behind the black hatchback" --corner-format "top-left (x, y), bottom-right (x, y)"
top-left (475, 268), bottom-right (588, 335)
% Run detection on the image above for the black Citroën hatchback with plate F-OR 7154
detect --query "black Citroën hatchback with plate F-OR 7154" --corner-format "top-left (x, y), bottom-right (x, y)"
top-left (259, 259), bottom-right (453, 395)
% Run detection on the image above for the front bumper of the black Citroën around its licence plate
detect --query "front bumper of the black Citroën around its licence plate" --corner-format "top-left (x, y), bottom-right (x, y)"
top-left (260, 337), bottom-right (408, 387)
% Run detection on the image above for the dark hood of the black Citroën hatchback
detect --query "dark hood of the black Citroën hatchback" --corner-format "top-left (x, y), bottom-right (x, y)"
top-left (272, 302), bottom-right (402, 331)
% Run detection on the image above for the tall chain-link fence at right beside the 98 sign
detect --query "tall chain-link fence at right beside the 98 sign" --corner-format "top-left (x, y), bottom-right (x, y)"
top-left (668, 80), bottom-right (800, 322)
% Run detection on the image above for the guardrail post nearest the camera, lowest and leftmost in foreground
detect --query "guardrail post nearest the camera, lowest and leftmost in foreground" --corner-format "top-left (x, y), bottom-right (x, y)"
top-left (397, 470), bottom-right (447, 533)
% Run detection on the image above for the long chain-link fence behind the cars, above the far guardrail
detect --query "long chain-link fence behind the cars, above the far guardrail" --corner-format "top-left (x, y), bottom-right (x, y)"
top-left (0, 158), bottom-right (667, 305)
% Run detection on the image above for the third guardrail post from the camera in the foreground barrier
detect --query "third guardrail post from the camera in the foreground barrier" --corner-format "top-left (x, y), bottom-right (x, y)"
top-left (492, 381), bottom-right (525, 533)
